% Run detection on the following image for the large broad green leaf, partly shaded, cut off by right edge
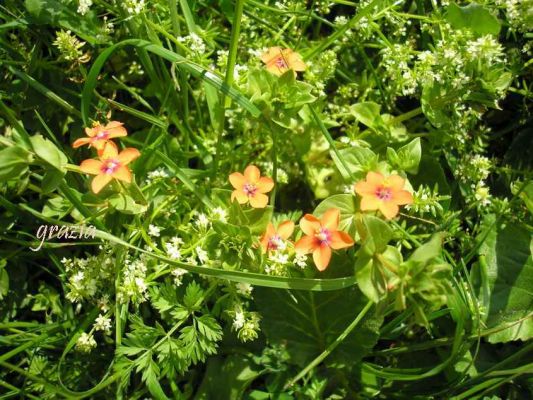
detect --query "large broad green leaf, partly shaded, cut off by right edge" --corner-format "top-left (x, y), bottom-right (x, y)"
top-left (473, 215), bottom-right (533, 343)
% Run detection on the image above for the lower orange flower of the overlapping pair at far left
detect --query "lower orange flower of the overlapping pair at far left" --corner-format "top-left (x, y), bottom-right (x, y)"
top-left (80, 142), bottom-right (141, 193)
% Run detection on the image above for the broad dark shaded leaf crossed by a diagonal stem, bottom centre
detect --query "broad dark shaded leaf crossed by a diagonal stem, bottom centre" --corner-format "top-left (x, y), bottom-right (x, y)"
top-left (254, 287), bottom-right (383, 366)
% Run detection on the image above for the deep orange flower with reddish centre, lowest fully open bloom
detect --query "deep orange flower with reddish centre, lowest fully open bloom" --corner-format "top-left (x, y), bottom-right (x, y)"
top-left (294, 208), bottom-right (354, 271)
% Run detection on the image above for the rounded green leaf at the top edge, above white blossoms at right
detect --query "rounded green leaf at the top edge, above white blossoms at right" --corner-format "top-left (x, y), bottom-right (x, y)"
top-left (446, 3), bottom-right (501, 36)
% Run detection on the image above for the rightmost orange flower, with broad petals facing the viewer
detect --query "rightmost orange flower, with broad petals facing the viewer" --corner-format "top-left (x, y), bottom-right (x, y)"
top-left (355, 172), bottom-right (413, 219)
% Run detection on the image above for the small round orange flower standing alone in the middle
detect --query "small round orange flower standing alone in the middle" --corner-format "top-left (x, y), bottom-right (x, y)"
top-left (229, 165), bottom-right (274, 208)
